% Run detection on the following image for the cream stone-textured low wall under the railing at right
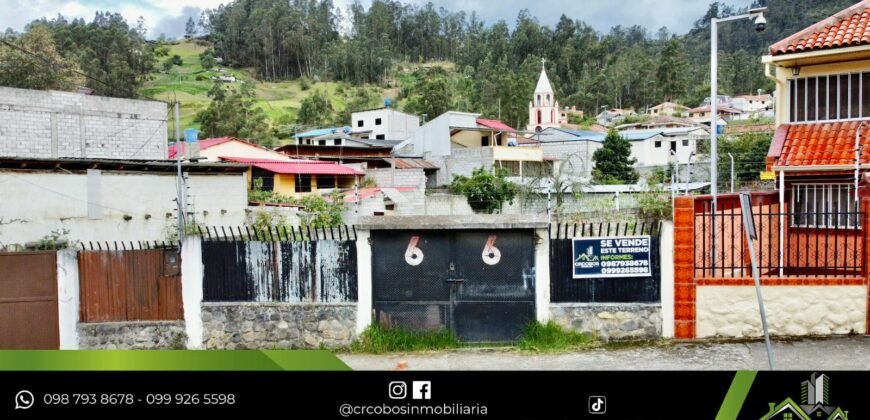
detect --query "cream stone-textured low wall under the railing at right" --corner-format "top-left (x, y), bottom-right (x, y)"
top-left (696, 285), bottom-right (867, 337)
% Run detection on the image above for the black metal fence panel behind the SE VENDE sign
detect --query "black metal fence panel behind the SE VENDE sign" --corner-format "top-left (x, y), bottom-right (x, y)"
top-left (550, 221), bottom-right (661, 303)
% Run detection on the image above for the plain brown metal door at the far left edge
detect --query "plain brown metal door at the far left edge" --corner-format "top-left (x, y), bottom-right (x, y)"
top-left (0, 251), bottom-right (60, 349)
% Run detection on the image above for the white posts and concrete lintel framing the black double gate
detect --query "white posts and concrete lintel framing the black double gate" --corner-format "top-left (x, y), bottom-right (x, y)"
top-left (356, 214), bottom-right (550, 334)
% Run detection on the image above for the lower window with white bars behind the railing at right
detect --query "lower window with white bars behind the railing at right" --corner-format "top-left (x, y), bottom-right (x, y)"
top-left (791, 184), bottom-right (861, 229)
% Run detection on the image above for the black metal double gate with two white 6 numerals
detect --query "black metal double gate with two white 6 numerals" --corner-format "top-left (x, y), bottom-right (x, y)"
top-left (372, 230), bottom-right (535, 342)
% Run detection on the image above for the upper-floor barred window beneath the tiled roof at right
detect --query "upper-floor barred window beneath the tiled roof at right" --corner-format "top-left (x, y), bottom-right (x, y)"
top-left (786, 73), bottom-right (870, 122)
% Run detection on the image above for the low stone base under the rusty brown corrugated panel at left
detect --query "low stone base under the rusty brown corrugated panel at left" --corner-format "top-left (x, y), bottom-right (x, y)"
top-left (78, 321), bottom-right (187, 350)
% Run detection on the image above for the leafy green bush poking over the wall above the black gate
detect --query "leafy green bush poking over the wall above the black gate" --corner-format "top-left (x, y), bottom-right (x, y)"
top-left (450, 167), bottom-right (519, 213)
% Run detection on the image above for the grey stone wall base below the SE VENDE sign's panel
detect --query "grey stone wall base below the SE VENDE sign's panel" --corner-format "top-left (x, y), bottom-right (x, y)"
top-left (550, 303), bottom-right (662, 341)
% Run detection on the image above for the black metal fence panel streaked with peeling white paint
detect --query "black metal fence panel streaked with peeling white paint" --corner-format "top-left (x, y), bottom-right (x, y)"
top-left (202, 226), bottom-right (357, 303)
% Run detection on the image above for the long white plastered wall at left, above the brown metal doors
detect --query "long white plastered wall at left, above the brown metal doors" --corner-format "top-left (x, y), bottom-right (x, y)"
top-left (0, 171), bottom-right (248, 245)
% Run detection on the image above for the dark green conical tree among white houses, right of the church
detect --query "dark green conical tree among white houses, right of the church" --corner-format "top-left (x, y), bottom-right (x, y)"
top-left (592, 128), bottom-right (638, 184)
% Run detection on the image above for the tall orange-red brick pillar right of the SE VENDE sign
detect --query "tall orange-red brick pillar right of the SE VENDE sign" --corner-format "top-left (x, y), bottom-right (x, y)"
top-left (674, 197), bottom-right (695, 339)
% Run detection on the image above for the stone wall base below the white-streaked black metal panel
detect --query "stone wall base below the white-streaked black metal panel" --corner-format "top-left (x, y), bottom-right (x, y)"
top-left (202, 302), bottom-right (357, 350)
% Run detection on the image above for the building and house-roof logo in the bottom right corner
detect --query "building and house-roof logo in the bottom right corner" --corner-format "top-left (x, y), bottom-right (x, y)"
top-left (761, 373), bottom-right (849, 420)
